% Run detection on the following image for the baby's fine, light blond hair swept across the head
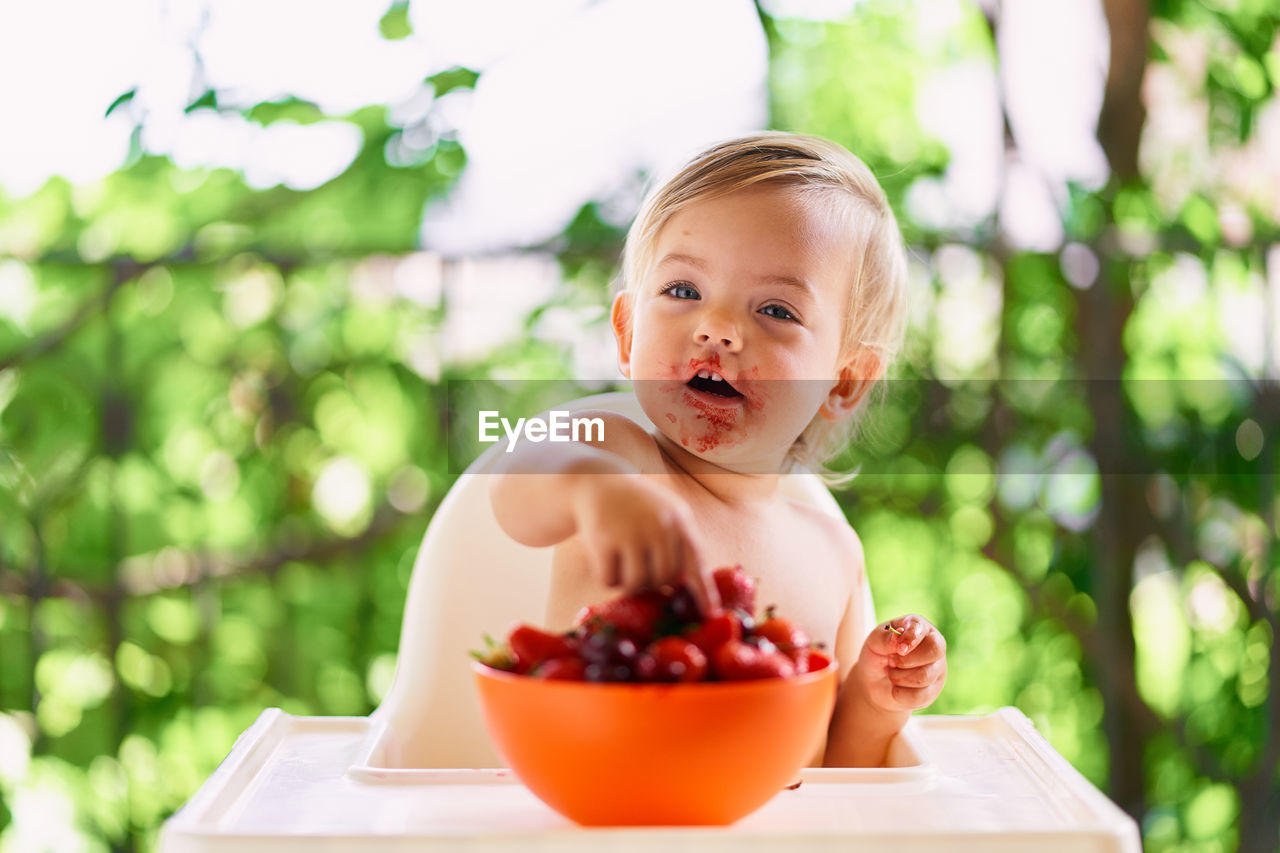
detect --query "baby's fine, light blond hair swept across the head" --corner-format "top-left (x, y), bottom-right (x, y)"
top-left (621, 131), bottom-right (906, 483)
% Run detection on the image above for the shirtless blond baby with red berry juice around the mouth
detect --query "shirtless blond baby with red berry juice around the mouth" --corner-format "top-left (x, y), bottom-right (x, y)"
top-left (492, 133), bottom-right (946, 766)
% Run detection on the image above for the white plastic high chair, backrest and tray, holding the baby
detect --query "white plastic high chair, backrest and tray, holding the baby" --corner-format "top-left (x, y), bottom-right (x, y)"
top-left (160, 394), bottom-right (1140, 853)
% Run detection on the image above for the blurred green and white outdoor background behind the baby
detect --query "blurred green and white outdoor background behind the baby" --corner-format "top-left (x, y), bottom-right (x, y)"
top-left (0, 0), bottom-right (1280, 852)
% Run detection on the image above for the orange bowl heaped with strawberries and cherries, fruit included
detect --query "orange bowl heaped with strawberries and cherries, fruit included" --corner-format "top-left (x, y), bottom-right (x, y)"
top-left (474, 567), bottom-right (836, 826)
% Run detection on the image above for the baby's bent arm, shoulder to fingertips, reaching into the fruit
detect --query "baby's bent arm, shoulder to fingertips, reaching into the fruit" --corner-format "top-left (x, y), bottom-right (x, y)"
top-left (490, 412), bottom-right (718, 612)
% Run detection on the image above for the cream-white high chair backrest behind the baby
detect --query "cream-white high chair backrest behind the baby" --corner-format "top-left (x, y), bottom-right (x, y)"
top-left (371, 393), bottom-right (870, 768)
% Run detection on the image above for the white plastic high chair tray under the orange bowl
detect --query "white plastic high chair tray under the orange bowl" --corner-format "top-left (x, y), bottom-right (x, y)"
top-left (160, 708), bottom-right (1140, 853)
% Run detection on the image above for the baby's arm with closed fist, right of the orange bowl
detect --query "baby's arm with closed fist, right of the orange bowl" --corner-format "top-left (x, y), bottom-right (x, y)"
top-left (823, 529), bottom-right (946, 767)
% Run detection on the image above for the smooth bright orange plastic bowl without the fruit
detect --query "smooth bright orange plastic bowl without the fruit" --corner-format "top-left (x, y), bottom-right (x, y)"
top-left (472, 656), bottom-right (836, 826)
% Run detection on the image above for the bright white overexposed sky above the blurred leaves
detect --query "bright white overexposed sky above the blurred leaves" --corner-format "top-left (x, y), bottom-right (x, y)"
top-left (0, 0), bottom-right (1106, 254)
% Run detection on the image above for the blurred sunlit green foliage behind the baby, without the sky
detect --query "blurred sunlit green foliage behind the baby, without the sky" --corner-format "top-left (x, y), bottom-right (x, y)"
top-left (0, 0), bottom-right (1280, 850)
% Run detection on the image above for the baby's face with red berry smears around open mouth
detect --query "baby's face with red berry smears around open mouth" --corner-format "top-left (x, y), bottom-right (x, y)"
top-left (618, 187), bottom-right (852, 473)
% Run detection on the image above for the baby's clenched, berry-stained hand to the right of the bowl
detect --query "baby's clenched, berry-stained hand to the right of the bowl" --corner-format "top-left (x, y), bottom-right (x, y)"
top-left (854, 615), bottom-right (947, 711)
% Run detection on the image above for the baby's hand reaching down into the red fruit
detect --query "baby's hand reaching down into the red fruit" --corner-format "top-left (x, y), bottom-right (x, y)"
top-left (573, 474), bottom-right (719, 613)
